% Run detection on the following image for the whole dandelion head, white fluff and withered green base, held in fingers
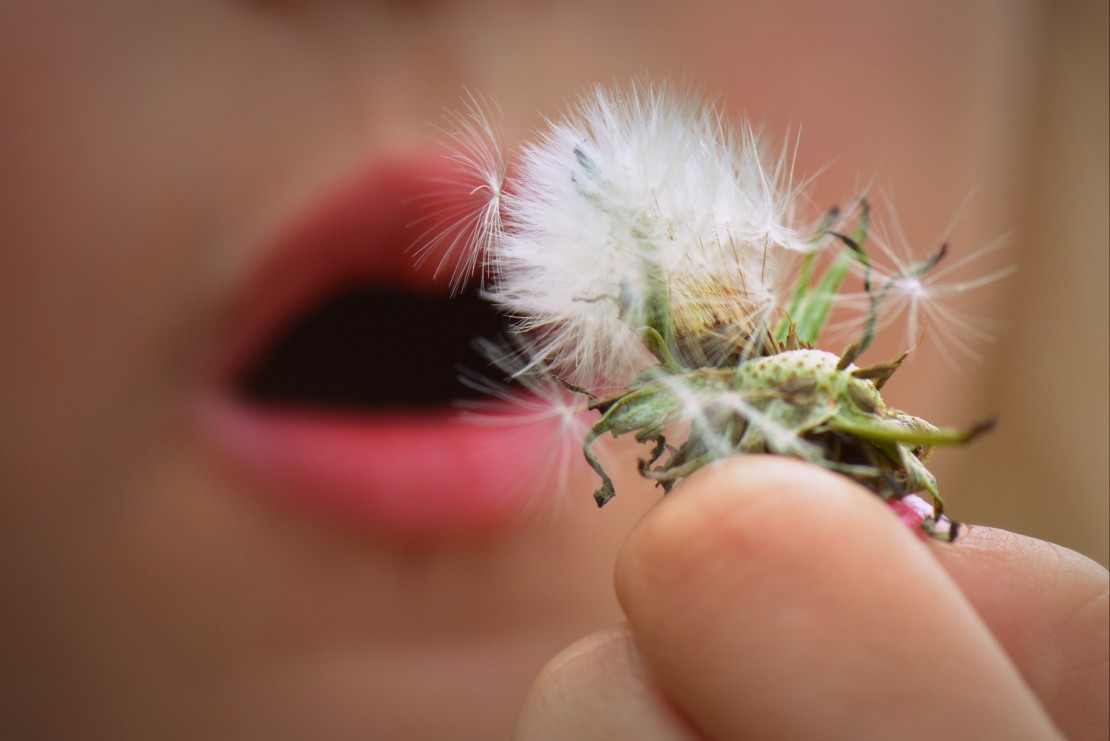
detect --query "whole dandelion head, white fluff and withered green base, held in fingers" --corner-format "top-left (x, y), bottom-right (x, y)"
top-left (428, 84), bottom-right (993, 539)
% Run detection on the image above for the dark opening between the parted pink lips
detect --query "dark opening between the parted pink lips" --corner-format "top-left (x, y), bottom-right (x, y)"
top-left (236, 285), bottom-right (506, 410)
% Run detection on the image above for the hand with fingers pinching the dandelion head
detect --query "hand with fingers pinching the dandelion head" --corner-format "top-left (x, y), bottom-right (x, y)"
top-left (517, 457), bottom-right (1108, 741)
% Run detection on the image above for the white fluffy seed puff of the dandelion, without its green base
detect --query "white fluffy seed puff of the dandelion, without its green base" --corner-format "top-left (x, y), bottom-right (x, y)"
top-left (432, 84), bottom-right (816, 390)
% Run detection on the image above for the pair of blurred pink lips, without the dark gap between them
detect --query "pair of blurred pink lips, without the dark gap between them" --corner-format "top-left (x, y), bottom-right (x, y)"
top-left (200, 160), bottom-right (559, 537)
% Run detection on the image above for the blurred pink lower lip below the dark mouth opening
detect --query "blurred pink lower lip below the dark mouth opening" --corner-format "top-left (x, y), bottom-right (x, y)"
top-left (201, 395), bottom-right (553, 537)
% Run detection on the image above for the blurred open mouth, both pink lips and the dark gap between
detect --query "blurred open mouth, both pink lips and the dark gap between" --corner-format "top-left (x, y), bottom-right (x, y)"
top-left (201, 157), bottom-right (551, 537)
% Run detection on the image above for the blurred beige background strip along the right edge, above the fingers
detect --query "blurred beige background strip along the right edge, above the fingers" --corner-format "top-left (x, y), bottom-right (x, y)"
top-left (948, 1), bottom-right (1110, 566)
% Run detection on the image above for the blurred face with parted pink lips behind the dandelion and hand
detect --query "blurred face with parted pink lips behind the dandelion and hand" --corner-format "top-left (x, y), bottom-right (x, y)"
top-left (0, 0), bottom-right (1038, 738)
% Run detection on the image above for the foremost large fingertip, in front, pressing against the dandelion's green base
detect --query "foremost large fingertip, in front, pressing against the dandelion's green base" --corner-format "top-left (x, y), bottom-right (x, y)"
top-left (616, 456), bottom-right (1058, 739)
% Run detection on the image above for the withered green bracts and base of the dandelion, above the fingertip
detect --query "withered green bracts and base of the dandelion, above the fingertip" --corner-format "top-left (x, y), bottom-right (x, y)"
top-left (573, 204), bottom-right (989, 539)
